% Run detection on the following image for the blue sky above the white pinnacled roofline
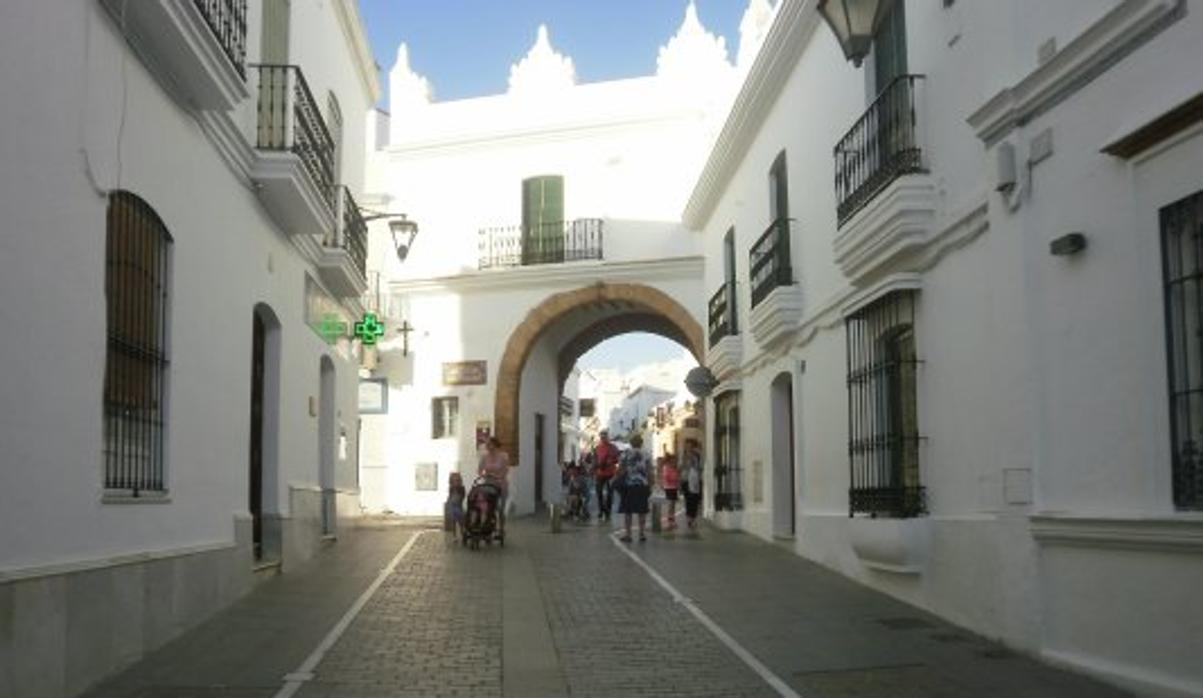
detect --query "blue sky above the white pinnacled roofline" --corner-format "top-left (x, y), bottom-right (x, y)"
top-left (360, 0), bottom-right (747, 100)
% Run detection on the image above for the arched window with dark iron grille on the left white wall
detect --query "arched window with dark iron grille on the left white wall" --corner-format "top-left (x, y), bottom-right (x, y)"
top-left (103, 191), bottom-right (172, 497)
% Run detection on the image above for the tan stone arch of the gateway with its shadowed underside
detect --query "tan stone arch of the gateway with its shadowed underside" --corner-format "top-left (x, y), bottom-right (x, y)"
top-left (493, 282), bottom-right (705, 463)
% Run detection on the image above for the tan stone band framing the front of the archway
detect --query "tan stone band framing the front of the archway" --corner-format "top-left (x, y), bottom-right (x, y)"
top-left (493, 282), bottom-right (705, 463)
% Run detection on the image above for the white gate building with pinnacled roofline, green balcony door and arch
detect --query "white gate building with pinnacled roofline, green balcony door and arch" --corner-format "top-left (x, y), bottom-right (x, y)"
top-left (353, 6), bottom-right (766, 514)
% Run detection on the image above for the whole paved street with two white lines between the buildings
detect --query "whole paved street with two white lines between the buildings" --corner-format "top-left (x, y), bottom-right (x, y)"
top-left (82, 514), bottom-right (1122, 698)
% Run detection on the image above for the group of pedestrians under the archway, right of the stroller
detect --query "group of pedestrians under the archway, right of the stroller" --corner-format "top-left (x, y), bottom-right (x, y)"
top-left (564, 430), bottom-right (701, 543)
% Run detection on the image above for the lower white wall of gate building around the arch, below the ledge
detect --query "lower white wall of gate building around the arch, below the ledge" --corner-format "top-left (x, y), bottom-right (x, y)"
top-left (363, 265), bottom-right (701, 515)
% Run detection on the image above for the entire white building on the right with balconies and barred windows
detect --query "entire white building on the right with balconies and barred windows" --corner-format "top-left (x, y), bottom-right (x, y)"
top-left (685, 0), bottom-right (1203, 696)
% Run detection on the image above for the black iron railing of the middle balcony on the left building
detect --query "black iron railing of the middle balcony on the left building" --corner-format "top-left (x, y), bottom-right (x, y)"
top-left (254, 65), bottom-right (334, 217)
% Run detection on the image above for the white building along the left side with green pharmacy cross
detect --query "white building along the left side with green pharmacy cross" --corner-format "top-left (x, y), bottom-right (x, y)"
top-left (0, 0), bottom-right (378, 697)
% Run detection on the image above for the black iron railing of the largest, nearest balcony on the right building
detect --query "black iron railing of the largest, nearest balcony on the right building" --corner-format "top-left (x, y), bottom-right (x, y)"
top-left (835, 75), bottom-right (926, 225)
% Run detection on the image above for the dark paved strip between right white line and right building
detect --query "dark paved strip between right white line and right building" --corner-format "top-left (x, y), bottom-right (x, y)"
top-left (636, 530), bottom-right (1127, 698)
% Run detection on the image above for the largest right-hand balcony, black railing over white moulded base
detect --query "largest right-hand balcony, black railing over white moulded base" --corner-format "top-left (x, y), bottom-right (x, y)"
top-left (832, 75), bottom-right (936, 283)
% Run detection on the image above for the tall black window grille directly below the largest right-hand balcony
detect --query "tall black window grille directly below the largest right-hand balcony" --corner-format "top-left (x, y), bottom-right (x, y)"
top-left (846, 291), bottom-right (926, 517)
